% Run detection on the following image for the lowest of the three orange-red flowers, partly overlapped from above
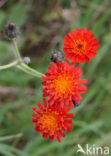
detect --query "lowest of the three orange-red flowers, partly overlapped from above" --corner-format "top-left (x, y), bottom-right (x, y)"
top-left (32, 99), bottom-right (73, 142)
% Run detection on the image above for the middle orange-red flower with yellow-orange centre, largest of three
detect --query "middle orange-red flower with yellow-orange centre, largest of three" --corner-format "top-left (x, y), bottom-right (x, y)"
top-left (42, 61), bottom-right (87, 107)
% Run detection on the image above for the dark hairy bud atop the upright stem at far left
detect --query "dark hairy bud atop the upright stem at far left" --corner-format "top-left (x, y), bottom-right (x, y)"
top-left (5, 22), bottom-right (18, 39)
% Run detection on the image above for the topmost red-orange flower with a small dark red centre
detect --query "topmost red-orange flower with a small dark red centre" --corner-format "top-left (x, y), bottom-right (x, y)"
top-left (63, 28), bottom-right (99, 63)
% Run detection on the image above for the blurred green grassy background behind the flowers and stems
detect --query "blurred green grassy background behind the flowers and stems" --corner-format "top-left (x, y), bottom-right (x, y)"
top-left (0, 0), bottom-right (111, 156)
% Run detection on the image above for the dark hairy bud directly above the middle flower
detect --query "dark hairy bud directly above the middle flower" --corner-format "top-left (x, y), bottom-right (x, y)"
top-left (50, 50), bottom-right (64, 63)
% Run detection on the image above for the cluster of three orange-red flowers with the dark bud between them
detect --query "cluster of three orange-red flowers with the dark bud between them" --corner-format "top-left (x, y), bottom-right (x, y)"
top-left (32, 29), bottom-right (99, 142)
